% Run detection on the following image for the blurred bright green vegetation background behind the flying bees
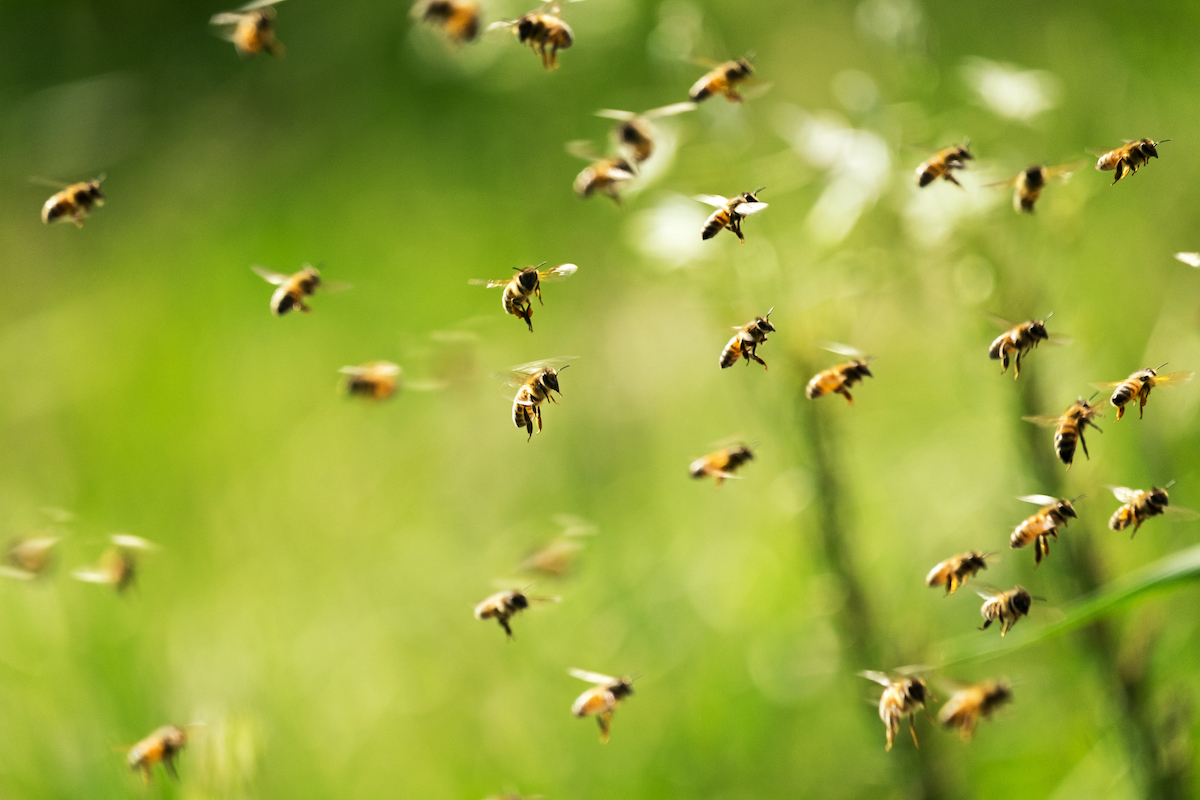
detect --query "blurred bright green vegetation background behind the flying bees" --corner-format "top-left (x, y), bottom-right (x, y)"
top-left (0, 0), bottom-right (1200, 800)
